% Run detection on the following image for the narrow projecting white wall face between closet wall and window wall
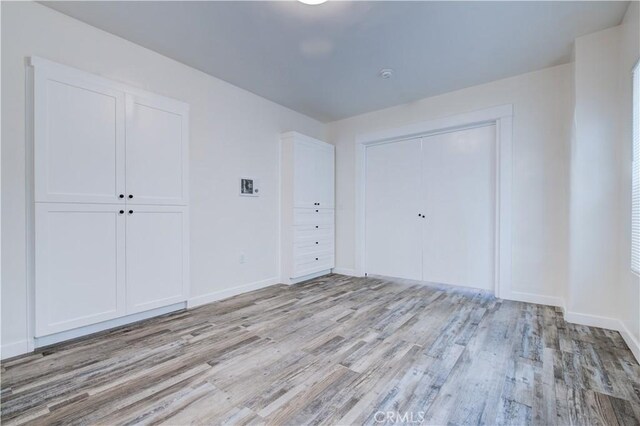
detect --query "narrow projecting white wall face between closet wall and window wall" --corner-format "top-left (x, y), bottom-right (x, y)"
top-left (567, 27), bottom-right (620, 318)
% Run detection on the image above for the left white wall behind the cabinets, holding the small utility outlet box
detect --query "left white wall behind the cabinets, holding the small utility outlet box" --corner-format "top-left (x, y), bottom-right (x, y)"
top-left (2, 2), bottom-right (325, 350)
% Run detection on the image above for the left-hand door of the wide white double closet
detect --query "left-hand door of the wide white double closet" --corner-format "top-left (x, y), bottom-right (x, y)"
top-left (365, 139), bottom-right (422, 280)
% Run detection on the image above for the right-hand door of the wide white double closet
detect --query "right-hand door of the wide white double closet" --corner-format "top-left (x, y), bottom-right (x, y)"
top-left (422, 126), bottom-right (496, 290)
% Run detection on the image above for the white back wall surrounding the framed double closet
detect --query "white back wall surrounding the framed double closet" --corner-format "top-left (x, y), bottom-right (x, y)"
top-left (328, 65), bottom-right (572, 300)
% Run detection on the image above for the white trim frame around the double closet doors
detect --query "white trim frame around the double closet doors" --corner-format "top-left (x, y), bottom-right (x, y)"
top-left (355, 104), bottom-right (513, 299)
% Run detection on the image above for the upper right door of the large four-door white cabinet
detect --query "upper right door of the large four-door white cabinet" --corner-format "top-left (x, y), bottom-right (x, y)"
top-left (126, 94), bottom-right (189, 205)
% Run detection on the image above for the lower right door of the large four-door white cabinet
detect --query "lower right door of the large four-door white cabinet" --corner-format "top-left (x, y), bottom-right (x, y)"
top-left (126, 206), bottom-right (189, 313)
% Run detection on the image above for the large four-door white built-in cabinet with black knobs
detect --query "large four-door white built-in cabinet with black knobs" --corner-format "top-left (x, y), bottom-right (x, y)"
top-left (32, 58), bottom-right (189, 337)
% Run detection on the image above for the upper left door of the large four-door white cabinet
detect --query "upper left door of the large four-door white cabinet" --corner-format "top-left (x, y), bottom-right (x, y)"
top-left (34, 65), bottom-right (125, 203)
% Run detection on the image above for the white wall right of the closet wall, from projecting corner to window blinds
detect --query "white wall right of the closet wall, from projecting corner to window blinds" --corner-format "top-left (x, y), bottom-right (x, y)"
top-left (567, 2), bottom-right (640, 350)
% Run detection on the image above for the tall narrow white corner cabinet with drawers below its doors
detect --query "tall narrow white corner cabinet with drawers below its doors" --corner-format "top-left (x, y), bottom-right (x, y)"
top-left (281, 132), bottom-right (335, 284)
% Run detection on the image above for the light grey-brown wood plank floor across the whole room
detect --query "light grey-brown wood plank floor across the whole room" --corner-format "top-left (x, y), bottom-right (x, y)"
top-left (1, 275), bottom-right (640, 425)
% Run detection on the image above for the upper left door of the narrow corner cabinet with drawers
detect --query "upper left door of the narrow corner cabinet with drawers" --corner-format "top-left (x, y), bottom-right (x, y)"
top-left (293, 141), bottom-right (318, 207)
